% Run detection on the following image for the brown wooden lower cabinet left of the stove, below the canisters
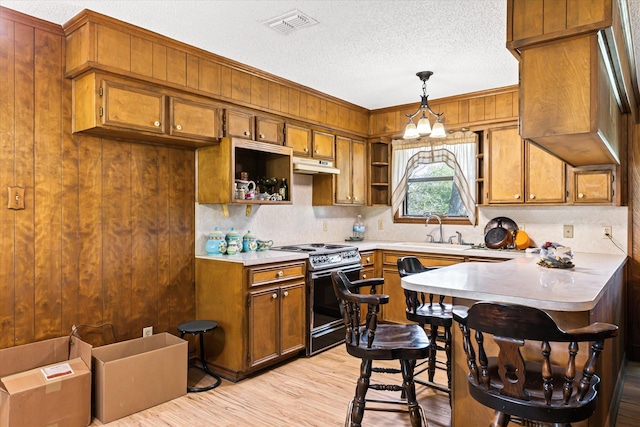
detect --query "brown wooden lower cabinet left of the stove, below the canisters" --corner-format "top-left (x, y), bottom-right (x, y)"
top-left (196, 258), bottom-right (306, 381)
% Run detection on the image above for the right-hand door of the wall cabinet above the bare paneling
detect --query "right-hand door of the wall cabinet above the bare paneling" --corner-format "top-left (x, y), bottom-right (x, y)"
top-left (169, 98), bottom-right (221, 140)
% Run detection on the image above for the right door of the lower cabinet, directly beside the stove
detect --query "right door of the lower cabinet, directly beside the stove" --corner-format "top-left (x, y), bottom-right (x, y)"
top-left (280, 282), bottom-right (307, 355)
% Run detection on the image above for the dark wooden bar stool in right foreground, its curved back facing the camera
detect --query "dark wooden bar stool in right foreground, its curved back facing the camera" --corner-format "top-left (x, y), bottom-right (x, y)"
top-left (453, 301), bottom-right (618, 427)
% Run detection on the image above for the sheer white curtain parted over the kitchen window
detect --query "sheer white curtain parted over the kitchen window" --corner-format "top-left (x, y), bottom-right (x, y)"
top-left (391, 132), bottom-right (478, 224)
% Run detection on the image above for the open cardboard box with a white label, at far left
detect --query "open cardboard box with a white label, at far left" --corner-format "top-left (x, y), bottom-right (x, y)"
top-left (0, 336), bottom-right (91, 427)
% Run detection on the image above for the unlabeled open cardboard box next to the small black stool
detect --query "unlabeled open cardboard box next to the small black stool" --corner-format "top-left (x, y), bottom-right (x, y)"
top-left (93, 332), bottom-right (189, 423)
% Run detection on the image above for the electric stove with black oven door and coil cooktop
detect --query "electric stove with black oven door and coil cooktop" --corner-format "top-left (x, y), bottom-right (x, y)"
top-left (272, 243), bottom-right (362, 356)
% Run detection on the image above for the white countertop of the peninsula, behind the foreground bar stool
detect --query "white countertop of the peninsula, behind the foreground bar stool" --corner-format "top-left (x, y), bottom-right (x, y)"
top-left (402, 253), bottom-right (626, 311)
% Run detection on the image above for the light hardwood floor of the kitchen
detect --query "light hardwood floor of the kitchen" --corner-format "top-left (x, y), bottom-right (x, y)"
top-left (92, 345), bottom-right (640, 427)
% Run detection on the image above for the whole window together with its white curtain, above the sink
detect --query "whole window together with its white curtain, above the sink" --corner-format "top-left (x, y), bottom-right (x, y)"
top-left (391, 132), bottom-right (478, 224)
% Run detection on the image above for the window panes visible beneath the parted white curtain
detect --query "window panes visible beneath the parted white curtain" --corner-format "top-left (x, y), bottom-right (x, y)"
top-left (403, 162), bottom-right (468, 218)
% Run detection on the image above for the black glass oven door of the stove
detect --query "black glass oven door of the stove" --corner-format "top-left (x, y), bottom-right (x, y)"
top-left (307, 264), bottom-right (362, 356)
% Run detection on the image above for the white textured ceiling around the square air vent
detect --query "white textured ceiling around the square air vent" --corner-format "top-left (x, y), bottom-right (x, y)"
top-left (0, 0), bottom-right (640, 109)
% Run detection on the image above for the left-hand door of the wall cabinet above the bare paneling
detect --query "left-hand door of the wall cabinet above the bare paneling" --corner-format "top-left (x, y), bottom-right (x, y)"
top-left (101, 80), bottom-right (166, 134)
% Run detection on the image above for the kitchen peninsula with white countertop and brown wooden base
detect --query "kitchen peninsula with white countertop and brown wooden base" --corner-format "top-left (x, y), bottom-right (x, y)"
top-left (401, 253), bottom-right (626, 427)
